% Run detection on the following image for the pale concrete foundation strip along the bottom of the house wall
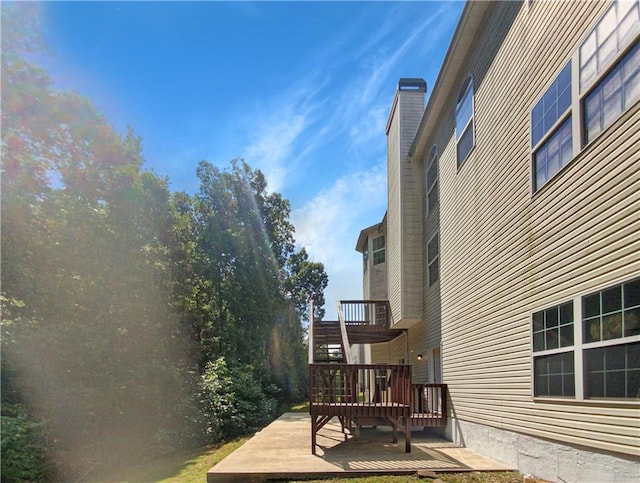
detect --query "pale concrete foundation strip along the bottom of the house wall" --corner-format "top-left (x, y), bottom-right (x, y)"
top-left (445, 418), bottom-right (640, 483)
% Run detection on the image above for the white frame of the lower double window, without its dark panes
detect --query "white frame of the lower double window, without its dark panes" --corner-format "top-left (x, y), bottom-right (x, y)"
top-left (529, 273), bottom-right (640, 404)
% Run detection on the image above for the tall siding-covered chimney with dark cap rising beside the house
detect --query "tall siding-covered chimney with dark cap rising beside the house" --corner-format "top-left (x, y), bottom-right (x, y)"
top-left (387, 78), bottom-right (427, 328)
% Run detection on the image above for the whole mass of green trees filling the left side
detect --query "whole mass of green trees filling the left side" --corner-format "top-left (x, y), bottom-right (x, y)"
top-left (1, 4), bottom-right (327, 481)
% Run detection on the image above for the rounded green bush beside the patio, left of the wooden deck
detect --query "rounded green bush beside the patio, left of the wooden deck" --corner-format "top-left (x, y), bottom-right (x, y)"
top-left (200, 357), bottom-right (278, 443)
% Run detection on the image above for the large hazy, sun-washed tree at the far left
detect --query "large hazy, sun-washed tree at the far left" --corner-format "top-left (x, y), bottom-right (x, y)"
top-left (1, 5), bottom-right (196, 478)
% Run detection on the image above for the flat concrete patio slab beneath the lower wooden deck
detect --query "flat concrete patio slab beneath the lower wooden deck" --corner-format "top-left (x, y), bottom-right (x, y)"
top-left (207, 413), bottom-right (515, 483)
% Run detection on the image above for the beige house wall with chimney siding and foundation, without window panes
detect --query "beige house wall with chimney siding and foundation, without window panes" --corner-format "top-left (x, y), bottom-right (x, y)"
top-left (358, 1), bottom-right (640, 481)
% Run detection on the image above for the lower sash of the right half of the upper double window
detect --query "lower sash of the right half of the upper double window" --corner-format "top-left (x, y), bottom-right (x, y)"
top-left (584, 44), bottom-right (640, 144)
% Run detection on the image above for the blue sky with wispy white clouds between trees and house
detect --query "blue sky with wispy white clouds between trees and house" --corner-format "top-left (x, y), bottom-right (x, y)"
top-left (37, 1), bottom-right (464, 318)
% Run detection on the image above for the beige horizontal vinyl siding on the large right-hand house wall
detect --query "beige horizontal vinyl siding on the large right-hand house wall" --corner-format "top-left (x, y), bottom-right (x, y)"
top-left (438, 2), bottom-right (640, 455)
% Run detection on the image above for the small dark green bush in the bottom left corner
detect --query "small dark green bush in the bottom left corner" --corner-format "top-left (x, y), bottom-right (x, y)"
top-left (0, 405), bottom-right (51, 483)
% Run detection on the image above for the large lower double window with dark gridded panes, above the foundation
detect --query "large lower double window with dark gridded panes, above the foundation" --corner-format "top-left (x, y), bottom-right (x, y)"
top-left (531, 278), bottom-right (640, 399)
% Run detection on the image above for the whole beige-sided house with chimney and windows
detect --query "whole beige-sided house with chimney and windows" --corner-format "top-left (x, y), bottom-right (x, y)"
top-left (312, 0), bottom-right (640, 482)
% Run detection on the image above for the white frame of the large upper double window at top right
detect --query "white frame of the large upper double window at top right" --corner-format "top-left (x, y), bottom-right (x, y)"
top-left (529, 0), bottom-right (640, 196)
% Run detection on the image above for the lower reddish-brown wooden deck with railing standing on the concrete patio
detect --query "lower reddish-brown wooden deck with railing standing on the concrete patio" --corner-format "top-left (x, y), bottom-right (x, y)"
top-left (309, 363), bottom-right (447, 454)
